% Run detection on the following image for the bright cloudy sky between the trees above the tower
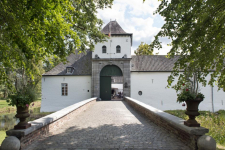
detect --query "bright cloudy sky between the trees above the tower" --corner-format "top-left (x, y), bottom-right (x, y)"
top-left (98, 0), bottom-right (170, 55)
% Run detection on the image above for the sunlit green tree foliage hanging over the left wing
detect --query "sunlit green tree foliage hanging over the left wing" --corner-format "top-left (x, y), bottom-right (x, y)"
top-left (0, 0), bottom-right (113, 88)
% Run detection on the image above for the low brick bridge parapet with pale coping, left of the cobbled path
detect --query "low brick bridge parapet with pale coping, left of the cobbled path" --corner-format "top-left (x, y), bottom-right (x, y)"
top-left (6, 98), bottom-right (97, 149)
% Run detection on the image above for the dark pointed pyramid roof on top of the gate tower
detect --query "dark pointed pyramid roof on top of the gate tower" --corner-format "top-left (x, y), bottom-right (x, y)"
top-left (102, 21), bottom-right (129, 34)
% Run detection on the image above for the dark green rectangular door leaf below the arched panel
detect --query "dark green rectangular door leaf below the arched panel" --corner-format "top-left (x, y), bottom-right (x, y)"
top-left (100, 76), bottom-right (111, 100)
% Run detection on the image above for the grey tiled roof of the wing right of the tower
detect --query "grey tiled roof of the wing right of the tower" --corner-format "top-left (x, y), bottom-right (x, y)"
top-left (131, 55), bottom-right (179, 72)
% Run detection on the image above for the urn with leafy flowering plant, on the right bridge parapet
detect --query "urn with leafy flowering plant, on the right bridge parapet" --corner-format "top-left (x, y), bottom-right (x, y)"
top-left (167, 65), bottom-right (206, 127)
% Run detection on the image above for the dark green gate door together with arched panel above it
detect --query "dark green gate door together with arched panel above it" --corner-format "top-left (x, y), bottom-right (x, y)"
top-left (100, 65), bottom-right (123, 100)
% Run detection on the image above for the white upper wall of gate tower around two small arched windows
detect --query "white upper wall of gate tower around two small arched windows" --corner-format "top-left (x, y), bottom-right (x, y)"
top-left (92, 36), bottom-right (131, 58)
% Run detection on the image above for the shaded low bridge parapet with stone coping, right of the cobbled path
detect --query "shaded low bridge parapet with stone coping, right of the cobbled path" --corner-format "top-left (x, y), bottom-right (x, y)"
top-left (124, 97), bottom-right (209, 150)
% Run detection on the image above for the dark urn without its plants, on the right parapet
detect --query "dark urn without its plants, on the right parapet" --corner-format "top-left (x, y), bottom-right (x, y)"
top-left (184, 98), bottom-right (203, 127)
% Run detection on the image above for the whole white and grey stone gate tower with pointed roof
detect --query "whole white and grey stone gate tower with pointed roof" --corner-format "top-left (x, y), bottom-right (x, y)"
top-left (91, 21), bottom-right (133, 100)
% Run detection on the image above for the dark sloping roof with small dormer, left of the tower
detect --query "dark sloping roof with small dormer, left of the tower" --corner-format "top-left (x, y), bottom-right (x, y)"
top-left (43, 51), bottom-right (92, 76)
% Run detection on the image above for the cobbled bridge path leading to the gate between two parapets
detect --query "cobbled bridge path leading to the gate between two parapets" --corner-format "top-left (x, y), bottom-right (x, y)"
top-left (27, 101), bottom-right (189, 150)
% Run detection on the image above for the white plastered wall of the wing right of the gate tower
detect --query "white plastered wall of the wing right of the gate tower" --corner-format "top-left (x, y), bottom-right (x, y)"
top-left (131, 72), bottom-right (225, 111)
